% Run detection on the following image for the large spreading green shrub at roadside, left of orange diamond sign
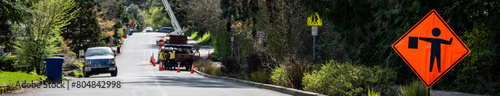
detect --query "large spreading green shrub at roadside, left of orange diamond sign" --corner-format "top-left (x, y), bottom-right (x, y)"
top-left (303, 60), bottom-right (396, 96)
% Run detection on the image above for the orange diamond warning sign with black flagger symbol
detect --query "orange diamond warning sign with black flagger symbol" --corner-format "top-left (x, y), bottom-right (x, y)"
top-left (392, 10), bottom-right (470, 88)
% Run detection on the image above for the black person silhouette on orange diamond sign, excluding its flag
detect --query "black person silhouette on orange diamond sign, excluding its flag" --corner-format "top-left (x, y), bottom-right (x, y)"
top-left (419, 28), bottom-right (453, 72)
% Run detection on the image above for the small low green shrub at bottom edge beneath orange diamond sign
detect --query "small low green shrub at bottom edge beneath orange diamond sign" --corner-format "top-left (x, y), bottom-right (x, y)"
top-left (399, 80), bottom-right (428, 96)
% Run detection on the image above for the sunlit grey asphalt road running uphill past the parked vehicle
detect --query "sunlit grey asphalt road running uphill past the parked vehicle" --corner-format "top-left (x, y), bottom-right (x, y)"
top-left (2, 33), bottom-right (286, 96)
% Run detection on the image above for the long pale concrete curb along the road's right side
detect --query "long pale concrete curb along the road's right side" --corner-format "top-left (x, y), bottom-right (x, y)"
top-left (194, 69), bottom-right (326, 96)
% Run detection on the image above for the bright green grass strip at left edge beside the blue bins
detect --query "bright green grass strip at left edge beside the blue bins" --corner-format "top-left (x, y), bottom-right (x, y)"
top-left (0, 72), bottom-right (46, 86)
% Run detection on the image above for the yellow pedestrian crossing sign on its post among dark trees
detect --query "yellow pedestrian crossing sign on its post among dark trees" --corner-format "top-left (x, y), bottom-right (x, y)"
top-left (307, 12), bottom-right (323, 61)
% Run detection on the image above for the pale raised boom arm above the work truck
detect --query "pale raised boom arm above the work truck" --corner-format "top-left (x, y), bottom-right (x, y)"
top-left (162, 0), bottom-right (182, 35)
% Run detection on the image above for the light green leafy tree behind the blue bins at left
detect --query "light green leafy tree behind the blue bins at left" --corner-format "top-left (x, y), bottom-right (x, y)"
top-left (13, 0), bottom-right (76, 74)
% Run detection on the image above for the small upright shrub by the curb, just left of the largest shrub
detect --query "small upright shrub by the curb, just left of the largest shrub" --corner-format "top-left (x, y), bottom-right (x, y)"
top-left (271, 66), bottom-right (292, 87)
